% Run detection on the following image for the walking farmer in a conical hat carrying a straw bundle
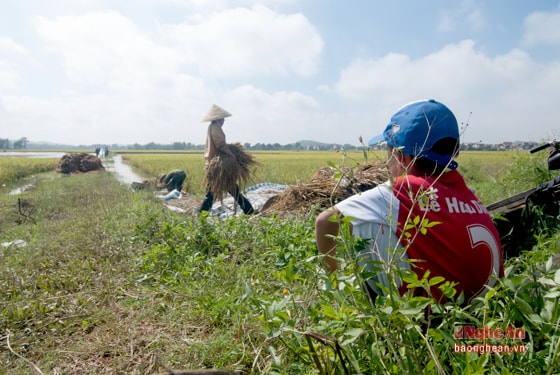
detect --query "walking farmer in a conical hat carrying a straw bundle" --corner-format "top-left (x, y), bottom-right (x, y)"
top-left (199, 104), bottom-right (255, 214)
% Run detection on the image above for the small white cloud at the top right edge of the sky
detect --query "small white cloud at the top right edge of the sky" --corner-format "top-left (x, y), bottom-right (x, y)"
top-left (523, 11), bottom-right (560, 46)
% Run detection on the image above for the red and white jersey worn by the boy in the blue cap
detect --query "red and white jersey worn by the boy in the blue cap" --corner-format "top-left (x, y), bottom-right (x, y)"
top-left (336, 171), bottom-right (503, 302)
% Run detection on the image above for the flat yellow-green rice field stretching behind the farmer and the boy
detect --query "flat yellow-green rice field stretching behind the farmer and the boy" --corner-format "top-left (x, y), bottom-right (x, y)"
top-left (122, 151), bottom-right (519, 203)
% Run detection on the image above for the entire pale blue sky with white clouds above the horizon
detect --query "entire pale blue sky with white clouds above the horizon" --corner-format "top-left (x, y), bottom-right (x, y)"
top-left (0, 0), bottom-right (560, 145)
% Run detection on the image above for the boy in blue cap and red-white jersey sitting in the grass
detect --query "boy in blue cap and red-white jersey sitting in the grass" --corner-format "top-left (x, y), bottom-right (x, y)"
top-left (315, 100), bottom-right (503, 303)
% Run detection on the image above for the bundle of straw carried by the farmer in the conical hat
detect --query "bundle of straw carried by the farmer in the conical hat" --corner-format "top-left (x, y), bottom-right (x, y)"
top-left (205, 143), bottom-right (261, 200)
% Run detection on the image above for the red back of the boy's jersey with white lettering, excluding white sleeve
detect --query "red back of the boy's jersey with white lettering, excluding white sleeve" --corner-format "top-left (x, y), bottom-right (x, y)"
top-left (393, 171), bottom-right (503, 301)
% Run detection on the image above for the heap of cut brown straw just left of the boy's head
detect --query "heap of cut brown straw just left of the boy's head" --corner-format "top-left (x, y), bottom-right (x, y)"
top-left (262, 161), bottom-right (389, 214)
